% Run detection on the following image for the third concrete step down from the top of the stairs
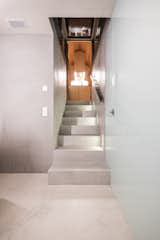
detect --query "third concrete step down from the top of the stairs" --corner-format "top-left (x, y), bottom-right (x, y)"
top-left (62, 117), bottom-right (97, 126)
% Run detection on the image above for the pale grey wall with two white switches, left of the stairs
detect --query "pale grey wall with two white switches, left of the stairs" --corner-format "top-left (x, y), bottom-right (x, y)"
top-left (0, 34), bottom-right (53, 172)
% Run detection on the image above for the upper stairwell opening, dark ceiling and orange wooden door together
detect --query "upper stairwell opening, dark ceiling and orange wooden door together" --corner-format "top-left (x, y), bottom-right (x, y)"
top-left (50, 18), bottom-right (109, 103)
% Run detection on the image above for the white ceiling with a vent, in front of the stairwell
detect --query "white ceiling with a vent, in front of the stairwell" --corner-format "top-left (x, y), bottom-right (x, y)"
top-left (0, 0), bottom-right (114, 34)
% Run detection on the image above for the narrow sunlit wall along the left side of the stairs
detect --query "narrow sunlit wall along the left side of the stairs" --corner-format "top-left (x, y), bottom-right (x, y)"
top-left (54, 34), bottom-right (67, 147)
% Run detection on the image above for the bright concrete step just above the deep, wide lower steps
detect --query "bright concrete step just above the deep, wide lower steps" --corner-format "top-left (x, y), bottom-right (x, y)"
top-left (58, 135), bottom-right (100, 146)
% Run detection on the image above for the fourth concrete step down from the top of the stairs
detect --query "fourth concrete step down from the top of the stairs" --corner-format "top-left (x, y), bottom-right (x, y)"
top-left (59, 125), bottom-right (100, 135)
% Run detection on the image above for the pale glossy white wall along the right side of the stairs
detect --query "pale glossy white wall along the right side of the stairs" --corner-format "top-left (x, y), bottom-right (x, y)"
top-left (106, 0), bottom-right (160, 240)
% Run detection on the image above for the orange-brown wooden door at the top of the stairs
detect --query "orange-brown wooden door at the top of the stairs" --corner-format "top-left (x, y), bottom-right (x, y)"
top-left (67, 41), bottom-right (92, 101)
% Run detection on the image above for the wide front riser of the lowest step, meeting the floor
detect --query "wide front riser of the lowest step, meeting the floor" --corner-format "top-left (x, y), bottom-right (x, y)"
top-left (48, 170), bottom-right (110, 185)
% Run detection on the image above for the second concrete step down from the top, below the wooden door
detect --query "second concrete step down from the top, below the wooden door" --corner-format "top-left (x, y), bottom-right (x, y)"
top-left (64, 110), bottom-right (96, 117)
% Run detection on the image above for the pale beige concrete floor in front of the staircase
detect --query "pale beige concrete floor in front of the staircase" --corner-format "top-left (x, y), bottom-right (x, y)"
top-left (0, 174), bottom-right (133, 240)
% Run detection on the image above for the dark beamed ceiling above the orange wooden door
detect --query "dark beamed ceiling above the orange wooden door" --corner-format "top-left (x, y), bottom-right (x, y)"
top-left (50, 17), bottom-right (110, 60)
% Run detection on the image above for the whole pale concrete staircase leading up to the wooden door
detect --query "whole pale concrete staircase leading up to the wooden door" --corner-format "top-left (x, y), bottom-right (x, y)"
top-left (48, 102), bottom-right (110, 185)
